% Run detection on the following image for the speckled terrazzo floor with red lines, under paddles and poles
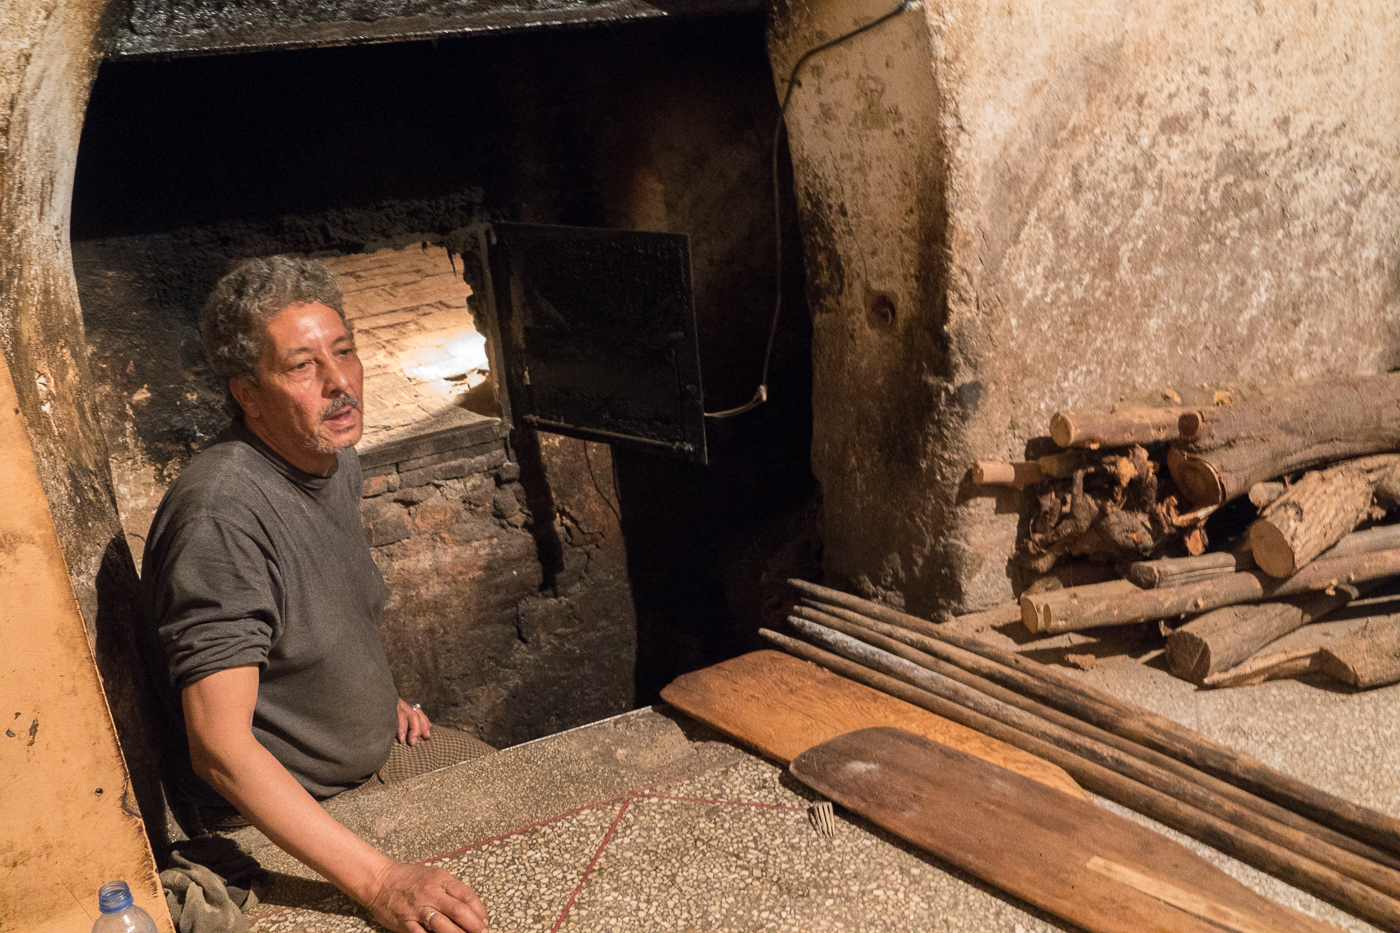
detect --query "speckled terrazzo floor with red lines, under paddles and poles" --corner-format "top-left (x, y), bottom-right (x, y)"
top-left (239, 652), bottom-right (1400, 933)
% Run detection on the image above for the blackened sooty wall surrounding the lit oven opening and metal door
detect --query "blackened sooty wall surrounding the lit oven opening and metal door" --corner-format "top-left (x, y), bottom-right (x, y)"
top-left (73, 17), bottom-right (816, 744)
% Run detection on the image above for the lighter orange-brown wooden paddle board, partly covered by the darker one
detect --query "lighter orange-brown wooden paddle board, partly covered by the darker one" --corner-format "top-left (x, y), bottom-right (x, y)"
top-left (661, 650), bottom-right (1086, 799)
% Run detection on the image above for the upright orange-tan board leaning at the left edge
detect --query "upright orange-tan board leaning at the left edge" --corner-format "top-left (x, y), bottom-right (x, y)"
top-left (0, 334), bottom-right (175, 933)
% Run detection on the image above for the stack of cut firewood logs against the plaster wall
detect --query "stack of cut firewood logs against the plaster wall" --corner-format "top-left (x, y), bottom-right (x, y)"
top-left (973, 374), bottom-right (1400, 686)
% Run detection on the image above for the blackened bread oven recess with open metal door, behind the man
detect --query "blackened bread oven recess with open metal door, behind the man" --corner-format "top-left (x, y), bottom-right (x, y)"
top-left (73, 3), bottom-right (813, 745)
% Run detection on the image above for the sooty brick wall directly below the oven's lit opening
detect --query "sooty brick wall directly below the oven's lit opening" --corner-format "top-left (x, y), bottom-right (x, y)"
top-left (361, 436), bottom-right (637, 745)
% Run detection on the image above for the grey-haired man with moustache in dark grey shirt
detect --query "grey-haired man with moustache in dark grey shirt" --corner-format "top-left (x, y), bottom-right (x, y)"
top-left (141, 256), bottom-right (486, 933)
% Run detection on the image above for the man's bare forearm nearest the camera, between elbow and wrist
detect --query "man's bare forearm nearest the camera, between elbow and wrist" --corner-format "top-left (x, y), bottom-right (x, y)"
top-left (192, 714), bottom-right (392, 904)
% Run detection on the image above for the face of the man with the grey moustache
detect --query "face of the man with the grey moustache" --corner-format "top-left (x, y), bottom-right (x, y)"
top-left (230, 301), bottom-right (364, 475)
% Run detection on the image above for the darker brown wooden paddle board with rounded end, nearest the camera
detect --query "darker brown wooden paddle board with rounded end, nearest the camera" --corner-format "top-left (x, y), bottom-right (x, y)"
top-left (791, 728), bottom-right (1337, 933)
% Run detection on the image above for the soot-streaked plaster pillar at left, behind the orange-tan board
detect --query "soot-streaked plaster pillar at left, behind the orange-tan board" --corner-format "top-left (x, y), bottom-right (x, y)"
top-left (0, 0), bottom-right (164, 843)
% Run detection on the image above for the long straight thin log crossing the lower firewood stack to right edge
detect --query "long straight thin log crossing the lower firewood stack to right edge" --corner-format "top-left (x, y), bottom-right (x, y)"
top-left (1021, 548), bottom-right (1400, 635)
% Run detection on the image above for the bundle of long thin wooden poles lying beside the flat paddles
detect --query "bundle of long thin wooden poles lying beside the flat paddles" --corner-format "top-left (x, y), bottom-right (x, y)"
top-left (764, 584), bottom-right (1400, 929)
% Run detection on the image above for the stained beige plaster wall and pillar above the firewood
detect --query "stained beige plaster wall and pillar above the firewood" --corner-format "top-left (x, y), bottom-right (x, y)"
top-left (770, 0), bottom-right (1400, 612)
